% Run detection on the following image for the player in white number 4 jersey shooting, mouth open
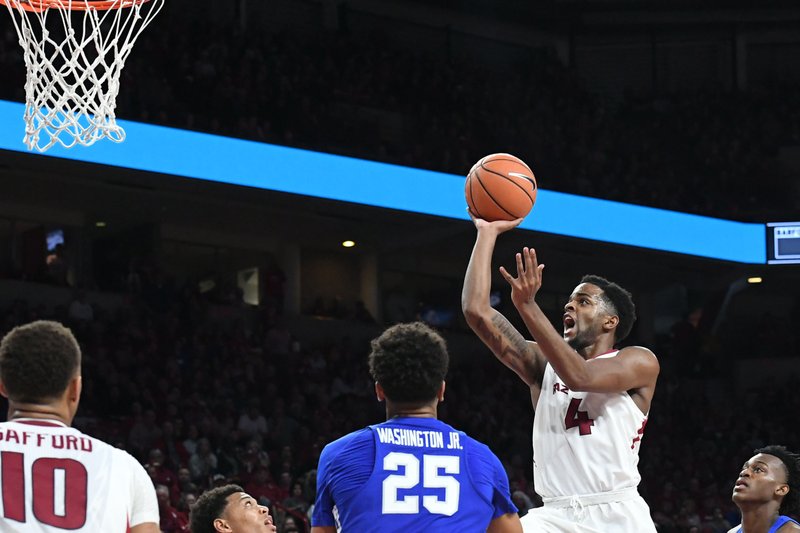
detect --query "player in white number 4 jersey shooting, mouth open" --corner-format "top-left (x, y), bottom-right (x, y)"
top-left (461, 214), bottom-right (659, 533)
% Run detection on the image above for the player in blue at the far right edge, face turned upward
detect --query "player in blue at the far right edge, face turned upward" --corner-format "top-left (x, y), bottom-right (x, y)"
top-left (728, 446), bottom-right (800, 533)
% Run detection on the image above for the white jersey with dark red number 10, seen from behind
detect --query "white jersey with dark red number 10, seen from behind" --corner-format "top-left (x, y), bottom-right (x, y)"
top-left (0, 419), bottom-right (159, 533)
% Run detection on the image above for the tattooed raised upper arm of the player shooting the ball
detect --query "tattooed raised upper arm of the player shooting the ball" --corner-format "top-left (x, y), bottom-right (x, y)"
top-left (465, 308), bottom-right (545, 386)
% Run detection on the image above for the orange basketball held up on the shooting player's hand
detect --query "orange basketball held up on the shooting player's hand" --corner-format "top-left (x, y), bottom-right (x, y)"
top-left (464, 154), bottom-right (537, 222)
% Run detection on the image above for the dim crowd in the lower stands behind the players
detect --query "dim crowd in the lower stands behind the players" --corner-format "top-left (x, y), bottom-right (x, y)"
top-left (0, 264), bottom-right (800, 533)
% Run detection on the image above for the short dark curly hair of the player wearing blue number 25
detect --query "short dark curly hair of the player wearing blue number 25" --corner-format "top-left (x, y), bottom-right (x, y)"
top-left (369, 322), bottom-right (450, 403)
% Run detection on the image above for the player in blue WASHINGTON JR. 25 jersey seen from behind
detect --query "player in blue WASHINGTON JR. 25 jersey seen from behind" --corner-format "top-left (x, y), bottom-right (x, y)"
top-left (311, 322), bottom-right (522, 533)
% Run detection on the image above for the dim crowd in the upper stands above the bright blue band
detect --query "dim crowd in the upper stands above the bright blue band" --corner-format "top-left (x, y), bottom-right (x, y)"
top-left (0, 15), bottom-right (800, 221)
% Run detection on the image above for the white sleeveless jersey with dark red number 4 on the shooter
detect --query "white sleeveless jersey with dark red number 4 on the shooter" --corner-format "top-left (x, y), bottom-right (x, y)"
top-left (533, 352), bottom-right (647, 498)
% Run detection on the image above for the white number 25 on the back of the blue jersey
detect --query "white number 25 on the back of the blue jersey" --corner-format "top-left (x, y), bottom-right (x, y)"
top-left (382, 452), bottom-right (461, 516)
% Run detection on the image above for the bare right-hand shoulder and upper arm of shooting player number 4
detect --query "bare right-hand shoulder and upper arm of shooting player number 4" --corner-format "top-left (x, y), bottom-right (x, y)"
top-left (580, 346), bottom-right (660, 392)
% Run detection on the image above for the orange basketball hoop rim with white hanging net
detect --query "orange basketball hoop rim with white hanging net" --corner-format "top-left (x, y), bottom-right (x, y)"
top-left (0, 0), bottom-right (165, 152)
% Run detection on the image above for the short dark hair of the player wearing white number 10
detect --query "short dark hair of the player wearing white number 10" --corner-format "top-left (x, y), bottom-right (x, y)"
top-left (0, 320), bottom-right (81, 403)
